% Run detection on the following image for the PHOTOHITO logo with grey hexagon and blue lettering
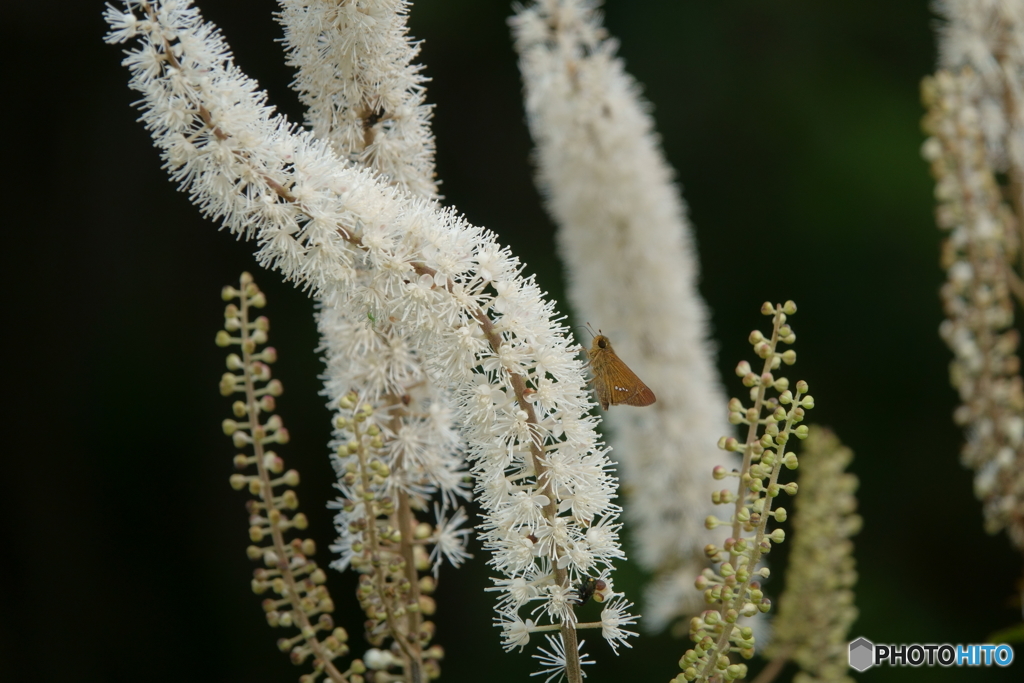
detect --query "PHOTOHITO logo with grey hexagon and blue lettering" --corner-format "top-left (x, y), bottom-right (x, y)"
top-left (850, 638), bottom-right (1014, 671)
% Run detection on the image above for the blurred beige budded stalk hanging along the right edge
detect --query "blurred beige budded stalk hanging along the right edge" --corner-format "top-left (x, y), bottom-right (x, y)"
top-left (922, 68), bottom-right (1024, 550)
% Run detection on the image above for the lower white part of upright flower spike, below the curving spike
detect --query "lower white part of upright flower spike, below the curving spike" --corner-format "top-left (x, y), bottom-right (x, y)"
top-left (317, 305), bottom-right (469, 574)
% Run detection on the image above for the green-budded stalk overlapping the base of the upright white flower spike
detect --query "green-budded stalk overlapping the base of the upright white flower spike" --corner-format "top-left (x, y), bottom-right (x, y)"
top-left (332, 392), bottom-right (444, 683)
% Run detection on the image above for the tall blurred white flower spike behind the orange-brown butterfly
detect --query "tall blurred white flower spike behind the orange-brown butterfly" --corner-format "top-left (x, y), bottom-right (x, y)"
top-left (511, 0), bottom-right (728, 630)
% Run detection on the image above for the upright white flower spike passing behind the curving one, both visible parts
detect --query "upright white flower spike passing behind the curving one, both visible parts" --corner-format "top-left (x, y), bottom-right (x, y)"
top-left (279, 0), bottom-right (469, 574)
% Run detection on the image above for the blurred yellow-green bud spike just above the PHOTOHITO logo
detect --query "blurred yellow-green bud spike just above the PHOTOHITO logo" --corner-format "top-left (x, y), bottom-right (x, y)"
top-left (755, 427), bottom-right (861, 683)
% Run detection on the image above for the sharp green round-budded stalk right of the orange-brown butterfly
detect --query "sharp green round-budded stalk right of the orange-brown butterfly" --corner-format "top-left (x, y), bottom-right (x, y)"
top-left (676, 301), bottom-right (814, 681)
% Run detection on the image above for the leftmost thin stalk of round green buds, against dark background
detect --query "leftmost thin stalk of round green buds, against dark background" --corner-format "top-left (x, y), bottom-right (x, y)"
top-left (216, 272), bottom-right (366, 683)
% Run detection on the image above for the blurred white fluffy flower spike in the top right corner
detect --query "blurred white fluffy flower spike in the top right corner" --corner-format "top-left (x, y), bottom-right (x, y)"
top-left (935, 0), bottom-right (1024, 176)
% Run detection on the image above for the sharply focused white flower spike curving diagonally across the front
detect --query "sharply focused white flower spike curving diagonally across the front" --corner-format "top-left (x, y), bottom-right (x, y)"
top-left (106, 0), bottom-right (626, 663)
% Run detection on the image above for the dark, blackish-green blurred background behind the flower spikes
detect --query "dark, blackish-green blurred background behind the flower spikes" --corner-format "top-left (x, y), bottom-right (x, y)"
top-left (0, 0), bottom-right (1024, 683)
